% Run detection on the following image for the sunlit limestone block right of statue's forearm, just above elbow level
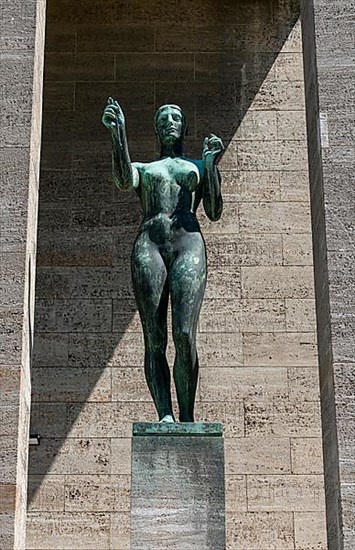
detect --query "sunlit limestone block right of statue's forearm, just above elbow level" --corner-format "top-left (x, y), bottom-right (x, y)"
top-left (222, 170), bottom-right (280, 202)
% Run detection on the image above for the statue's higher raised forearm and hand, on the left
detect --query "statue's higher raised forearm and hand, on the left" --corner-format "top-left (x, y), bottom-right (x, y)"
top-left (102, 97), bottom-right (139, 189)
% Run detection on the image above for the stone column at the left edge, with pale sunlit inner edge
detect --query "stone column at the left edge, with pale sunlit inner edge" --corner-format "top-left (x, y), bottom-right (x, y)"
top-left (0, 0), bottom-right (46, 550)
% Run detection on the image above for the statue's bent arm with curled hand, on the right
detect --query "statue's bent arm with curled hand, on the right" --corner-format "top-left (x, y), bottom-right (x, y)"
top-left (202, 134), bottom-right (224, 222)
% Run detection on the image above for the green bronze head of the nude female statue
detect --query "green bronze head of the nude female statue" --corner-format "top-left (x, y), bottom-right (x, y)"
top-left (155, 105), bottom-right (186, 146)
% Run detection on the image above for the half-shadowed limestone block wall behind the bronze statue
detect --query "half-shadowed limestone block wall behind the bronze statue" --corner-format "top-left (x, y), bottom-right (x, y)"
top-left (27, 0), bottom-right (326, 550)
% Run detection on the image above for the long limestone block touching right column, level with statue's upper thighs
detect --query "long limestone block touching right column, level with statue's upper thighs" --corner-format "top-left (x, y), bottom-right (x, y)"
top-left (241, 266), bottom-right (313, 299)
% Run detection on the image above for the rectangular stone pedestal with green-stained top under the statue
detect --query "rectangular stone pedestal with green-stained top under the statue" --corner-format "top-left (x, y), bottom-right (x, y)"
top-left (131, 422), bottom-right (225, 550)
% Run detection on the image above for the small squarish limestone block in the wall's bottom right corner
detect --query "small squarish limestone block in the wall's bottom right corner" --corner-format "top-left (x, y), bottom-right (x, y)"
top-left (295, 512), bottom-right (328, 550)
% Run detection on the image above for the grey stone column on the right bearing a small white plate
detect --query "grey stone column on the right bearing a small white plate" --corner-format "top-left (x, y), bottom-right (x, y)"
top-left (302, 0), bottom-right (355, 550)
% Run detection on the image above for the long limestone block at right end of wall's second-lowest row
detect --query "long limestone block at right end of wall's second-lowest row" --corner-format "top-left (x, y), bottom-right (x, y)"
top-left (247, 475), bottom-right (325, 512)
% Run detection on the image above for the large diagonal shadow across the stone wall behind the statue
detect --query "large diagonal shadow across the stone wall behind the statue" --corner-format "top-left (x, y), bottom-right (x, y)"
top-left (29, 0), bottom-right (299, 500)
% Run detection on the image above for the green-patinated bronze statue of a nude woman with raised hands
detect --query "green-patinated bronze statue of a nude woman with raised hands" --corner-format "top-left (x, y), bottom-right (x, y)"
top-left (102, 98), bottom-right (223, 422)
